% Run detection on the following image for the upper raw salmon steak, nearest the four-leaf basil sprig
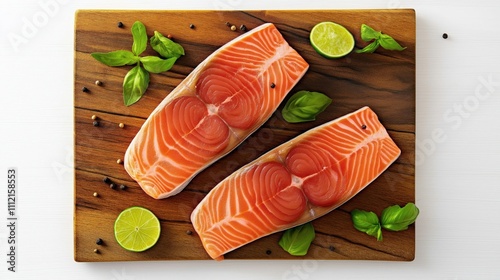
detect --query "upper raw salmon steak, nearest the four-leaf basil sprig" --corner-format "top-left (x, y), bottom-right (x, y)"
top-left (124, 23), bottom-right (309, 199)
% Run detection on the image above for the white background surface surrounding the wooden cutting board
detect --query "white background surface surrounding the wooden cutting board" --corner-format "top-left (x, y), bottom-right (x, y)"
top-left (0, 0), bottom-right (500, 280)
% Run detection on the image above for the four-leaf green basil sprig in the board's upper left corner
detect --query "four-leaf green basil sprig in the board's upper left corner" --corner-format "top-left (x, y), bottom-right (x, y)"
top-left (91, 21), bottom-right (184, 106)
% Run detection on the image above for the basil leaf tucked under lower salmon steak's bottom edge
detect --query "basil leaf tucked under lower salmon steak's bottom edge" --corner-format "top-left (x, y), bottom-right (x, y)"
top-left (278, 223), bottom-right (316, 256)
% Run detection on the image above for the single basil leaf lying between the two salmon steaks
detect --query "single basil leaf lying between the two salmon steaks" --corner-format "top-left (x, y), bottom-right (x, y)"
top-left (281, 90), bottom-right (332, 123)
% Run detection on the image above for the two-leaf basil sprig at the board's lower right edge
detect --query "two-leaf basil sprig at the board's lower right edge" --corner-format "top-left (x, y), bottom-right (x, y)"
top-left (351, 202), bottom-right (420, 241)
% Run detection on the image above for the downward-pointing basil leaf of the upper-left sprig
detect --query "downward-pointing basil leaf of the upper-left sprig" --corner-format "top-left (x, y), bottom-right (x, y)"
top-left (123, 65), bottom-right (149, 106)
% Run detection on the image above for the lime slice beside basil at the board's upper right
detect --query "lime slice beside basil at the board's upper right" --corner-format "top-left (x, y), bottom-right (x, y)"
top-left (309, 21), bottom-right (354, 58)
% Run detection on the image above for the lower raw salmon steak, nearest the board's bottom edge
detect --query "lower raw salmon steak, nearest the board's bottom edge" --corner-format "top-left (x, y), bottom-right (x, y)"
top-left (191, 107), bottom-right (401, 260)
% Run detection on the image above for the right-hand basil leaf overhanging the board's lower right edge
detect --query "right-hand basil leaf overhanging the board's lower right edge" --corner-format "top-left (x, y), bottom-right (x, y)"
top-left (380, 203), bottom-right (420, 231)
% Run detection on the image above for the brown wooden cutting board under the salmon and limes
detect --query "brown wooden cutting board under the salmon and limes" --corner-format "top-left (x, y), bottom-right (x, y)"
top-left (74, 10), bottom-right (415, 262)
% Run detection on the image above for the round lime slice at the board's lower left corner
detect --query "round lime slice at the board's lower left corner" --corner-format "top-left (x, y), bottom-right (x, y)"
top-left (115, 206), bottom-right (160, 252)
